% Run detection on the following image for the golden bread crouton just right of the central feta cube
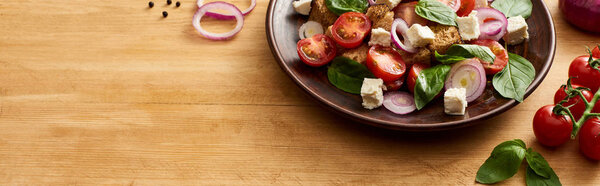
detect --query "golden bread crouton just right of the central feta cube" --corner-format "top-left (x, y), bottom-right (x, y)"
top-left (427, 25), bottom-right (462, 54)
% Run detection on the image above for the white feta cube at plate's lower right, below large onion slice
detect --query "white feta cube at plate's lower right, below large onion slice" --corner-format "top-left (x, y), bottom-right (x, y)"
top-left (444, 88), bottom-right (467, 115)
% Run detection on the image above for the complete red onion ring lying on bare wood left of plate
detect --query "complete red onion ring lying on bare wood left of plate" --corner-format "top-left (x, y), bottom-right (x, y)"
top-left (192, 1), bottom-right (244, 40)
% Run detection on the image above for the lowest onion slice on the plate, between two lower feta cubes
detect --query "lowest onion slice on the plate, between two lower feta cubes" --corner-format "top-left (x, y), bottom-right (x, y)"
top-left (383, 91), bottom-right (417, 114)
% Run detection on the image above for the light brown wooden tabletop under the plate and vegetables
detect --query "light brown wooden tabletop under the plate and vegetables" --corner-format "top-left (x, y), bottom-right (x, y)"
top-left (0, 0), bottom-right (600, 185)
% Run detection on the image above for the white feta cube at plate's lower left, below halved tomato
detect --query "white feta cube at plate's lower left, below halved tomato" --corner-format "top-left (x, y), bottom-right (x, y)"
top-left (360, 78), bottom-right (385, 110)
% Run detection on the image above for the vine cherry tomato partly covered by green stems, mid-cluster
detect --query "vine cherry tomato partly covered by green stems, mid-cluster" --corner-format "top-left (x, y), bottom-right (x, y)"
top-left (554, 85), bottom-right (600, 120)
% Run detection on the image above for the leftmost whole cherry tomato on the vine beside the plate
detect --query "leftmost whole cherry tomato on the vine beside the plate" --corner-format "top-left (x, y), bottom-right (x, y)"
top-left (533, 105), bottom-right (573, 147)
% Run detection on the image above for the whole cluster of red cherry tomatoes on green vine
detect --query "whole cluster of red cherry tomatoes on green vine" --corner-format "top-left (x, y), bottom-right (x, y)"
top-left (533, 46), bottom-right (600, 160)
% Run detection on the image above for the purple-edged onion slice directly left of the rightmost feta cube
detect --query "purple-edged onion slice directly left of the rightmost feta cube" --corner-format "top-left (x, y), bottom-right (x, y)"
top-left (475, 8), bottom-right (508, 41)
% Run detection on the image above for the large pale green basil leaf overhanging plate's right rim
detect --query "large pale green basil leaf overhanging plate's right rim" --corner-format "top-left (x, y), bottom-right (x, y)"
top-left (492, 52), bottom-right (535, 102)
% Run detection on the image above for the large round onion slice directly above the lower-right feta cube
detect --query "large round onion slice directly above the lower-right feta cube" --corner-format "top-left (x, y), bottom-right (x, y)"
top-left (445, 58), bottom-right (487, 102)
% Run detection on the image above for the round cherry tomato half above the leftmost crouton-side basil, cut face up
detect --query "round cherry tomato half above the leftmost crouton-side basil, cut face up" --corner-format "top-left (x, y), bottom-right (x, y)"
top-left (331, 12), bottom-right (371, 48)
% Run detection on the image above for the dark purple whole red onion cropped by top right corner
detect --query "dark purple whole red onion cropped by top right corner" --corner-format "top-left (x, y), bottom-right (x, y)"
top-left (559, 0), bottom-right (600, 33)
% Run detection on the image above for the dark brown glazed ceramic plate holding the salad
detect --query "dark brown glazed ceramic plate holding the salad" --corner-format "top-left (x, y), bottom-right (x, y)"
top-left (266, 0), bottom-right (556, 131)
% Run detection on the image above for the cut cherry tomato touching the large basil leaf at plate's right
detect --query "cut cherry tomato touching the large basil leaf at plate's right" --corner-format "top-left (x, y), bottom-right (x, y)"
top-left (472, 39), bottom-right (508, 75)
